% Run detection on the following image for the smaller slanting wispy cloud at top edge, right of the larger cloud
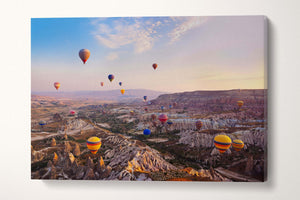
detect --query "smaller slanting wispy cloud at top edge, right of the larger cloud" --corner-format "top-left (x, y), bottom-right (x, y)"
top-left (168, 17), bottom-right (208, 44)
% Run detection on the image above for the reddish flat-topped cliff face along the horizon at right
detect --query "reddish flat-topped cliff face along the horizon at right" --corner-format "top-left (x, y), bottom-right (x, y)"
top-left (151, 90), bottom-right (267, 118)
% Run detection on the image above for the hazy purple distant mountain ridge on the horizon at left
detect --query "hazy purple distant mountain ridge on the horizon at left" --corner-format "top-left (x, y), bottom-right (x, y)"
top-left (31, 89), bottom-right (165, 102)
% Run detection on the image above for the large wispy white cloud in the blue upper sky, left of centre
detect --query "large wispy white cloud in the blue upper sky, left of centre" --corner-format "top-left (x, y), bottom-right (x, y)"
top-left (93, 19), bottom-right (161, 53)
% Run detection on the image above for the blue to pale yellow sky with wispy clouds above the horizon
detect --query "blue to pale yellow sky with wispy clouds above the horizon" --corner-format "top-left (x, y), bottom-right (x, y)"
top-left (31, 16), bottom-right (265, 92)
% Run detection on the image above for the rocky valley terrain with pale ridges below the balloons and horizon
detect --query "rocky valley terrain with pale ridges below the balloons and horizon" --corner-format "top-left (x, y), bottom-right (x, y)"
top-left (31, 90), bottom-right (267, 181)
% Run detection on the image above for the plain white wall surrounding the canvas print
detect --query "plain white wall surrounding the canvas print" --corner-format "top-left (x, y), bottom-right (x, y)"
top-left (0, 0), bottom-right (300, 200)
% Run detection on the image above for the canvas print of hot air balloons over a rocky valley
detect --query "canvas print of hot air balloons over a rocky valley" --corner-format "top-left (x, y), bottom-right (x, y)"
top-left (31, 16), bottom-right (267, 182)
